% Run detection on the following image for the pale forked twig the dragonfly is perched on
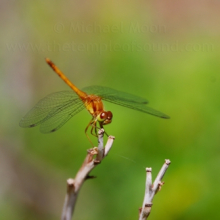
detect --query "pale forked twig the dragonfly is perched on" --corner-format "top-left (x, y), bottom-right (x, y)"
top-left (61, 129), bottom-right (114, 220)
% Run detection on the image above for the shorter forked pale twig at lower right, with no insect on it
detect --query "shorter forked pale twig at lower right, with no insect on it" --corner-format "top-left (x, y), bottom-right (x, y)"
top-left (139, 160), bottom-right (171, 220)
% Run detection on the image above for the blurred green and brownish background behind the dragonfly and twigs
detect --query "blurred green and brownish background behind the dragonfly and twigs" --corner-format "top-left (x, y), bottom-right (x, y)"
top-left (0, 0), bottom-right (220, 220)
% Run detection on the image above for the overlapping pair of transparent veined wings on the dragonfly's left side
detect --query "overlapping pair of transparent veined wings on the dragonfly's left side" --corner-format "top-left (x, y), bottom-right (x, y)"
top-left (19, 91), bottom-right (84, 133)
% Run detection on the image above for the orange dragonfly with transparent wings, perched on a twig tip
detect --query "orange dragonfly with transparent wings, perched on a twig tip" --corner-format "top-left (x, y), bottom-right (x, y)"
top-left (19, 58), bottom-right (169, 145)
